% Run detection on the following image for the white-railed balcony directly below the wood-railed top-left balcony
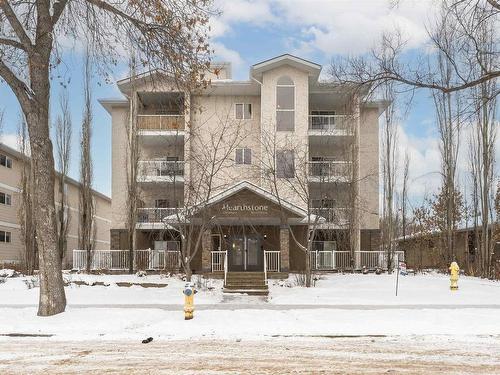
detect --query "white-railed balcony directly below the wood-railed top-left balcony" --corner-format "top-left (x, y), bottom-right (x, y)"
top-left (137, 160), bottom-right (184, 182)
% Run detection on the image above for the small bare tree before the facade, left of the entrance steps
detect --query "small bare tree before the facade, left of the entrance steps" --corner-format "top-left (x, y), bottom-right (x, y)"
top-left (165, 106), bottom-right (248, 281)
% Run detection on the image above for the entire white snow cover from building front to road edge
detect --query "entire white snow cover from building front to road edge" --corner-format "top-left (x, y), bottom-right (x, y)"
top-left (0, 274), bottom-right (500, 341)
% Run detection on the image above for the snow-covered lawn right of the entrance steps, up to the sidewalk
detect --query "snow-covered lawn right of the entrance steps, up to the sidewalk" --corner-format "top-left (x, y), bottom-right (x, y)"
top-left (270, 273), bottom-right (500, 307)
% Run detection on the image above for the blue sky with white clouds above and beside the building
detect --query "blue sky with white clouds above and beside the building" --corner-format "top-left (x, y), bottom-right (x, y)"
top-left (0, 0), bottom-right (500, 212)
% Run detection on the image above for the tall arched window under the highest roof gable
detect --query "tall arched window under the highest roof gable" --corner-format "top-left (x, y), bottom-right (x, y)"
top-left (276, 76), bottom-right (295, 131)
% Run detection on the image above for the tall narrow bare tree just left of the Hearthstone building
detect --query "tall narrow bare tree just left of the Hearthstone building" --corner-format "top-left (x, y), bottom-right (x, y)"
top-left (78, 53), bottom-right (96, 272)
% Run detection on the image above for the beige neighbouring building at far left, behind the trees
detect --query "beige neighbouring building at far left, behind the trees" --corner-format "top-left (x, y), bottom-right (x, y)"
top-left (0, 143), bottom-right (111, 268)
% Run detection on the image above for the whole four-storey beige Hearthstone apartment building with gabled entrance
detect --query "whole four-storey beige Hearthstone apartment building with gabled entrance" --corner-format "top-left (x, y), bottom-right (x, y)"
top-left (100, 54), bottom-right (385, 273)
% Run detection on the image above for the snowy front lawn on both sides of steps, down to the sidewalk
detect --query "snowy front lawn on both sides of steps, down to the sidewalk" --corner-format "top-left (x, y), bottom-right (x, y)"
top-left (0, 274), bottom-right (500, 307)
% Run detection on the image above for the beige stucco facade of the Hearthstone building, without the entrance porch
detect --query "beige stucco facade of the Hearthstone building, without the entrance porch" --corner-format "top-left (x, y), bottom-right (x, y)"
top-left (101, 55), bottom-right (384, 274)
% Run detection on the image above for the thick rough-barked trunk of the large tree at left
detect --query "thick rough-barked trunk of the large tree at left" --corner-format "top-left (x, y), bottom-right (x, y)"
top-left (23, 41), bottom-right (66, 316)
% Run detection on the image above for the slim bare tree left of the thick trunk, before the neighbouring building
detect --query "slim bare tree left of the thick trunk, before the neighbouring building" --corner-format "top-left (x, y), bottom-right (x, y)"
top-left (18, 118), bottom-right (38, 275)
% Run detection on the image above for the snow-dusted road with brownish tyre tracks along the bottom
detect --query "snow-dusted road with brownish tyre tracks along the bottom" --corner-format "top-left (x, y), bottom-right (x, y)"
top-left (0, 336), bottom-right (500, 375)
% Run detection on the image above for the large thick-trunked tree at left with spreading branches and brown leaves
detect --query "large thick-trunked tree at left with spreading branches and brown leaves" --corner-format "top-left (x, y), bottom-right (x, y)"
top-left (0, 0), bottom-right (211, 316)
